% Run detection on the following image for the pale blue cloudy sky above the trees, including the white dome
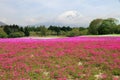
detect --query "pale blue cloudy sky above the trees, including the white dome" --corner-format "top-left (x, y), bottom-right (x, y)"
top-left (0, 0), bottom-right (120, 27)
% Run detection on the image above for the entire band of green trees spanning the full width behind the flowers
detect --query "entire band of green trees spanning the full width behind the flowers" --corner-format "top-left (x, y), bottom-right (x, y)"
top-left (0, 18), bottom-right (120, 38)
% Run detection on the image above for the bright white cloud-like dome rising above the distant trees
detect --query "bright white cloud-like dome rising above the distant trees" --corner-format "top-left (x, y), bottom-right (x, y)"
top-left (56, 10), bottom-right (89, 26)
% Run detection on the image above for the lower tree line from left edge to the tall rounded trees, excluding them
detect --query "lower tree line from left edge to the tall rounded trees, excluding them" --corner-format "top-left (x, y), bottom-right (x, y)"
top-left (0, 25), bottom-right (87, 38)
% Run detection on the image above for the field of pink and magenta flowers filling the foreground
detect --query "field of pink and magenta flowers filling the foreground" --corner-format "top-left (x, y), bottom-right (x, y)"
top-left (0, 37), bottom-right (120, 80)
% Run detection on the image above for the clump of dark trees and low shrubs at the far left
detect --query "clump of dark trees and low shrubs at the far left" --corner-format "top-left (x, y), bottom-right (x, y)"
top-left (0, 24), bottom-right (30, 38)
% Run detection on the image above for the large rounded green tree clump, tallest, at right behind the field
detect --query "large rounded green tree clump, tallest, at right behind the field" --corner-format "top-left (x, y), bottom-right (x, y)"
top-left (88, 18), bottom-right (118, 35)
